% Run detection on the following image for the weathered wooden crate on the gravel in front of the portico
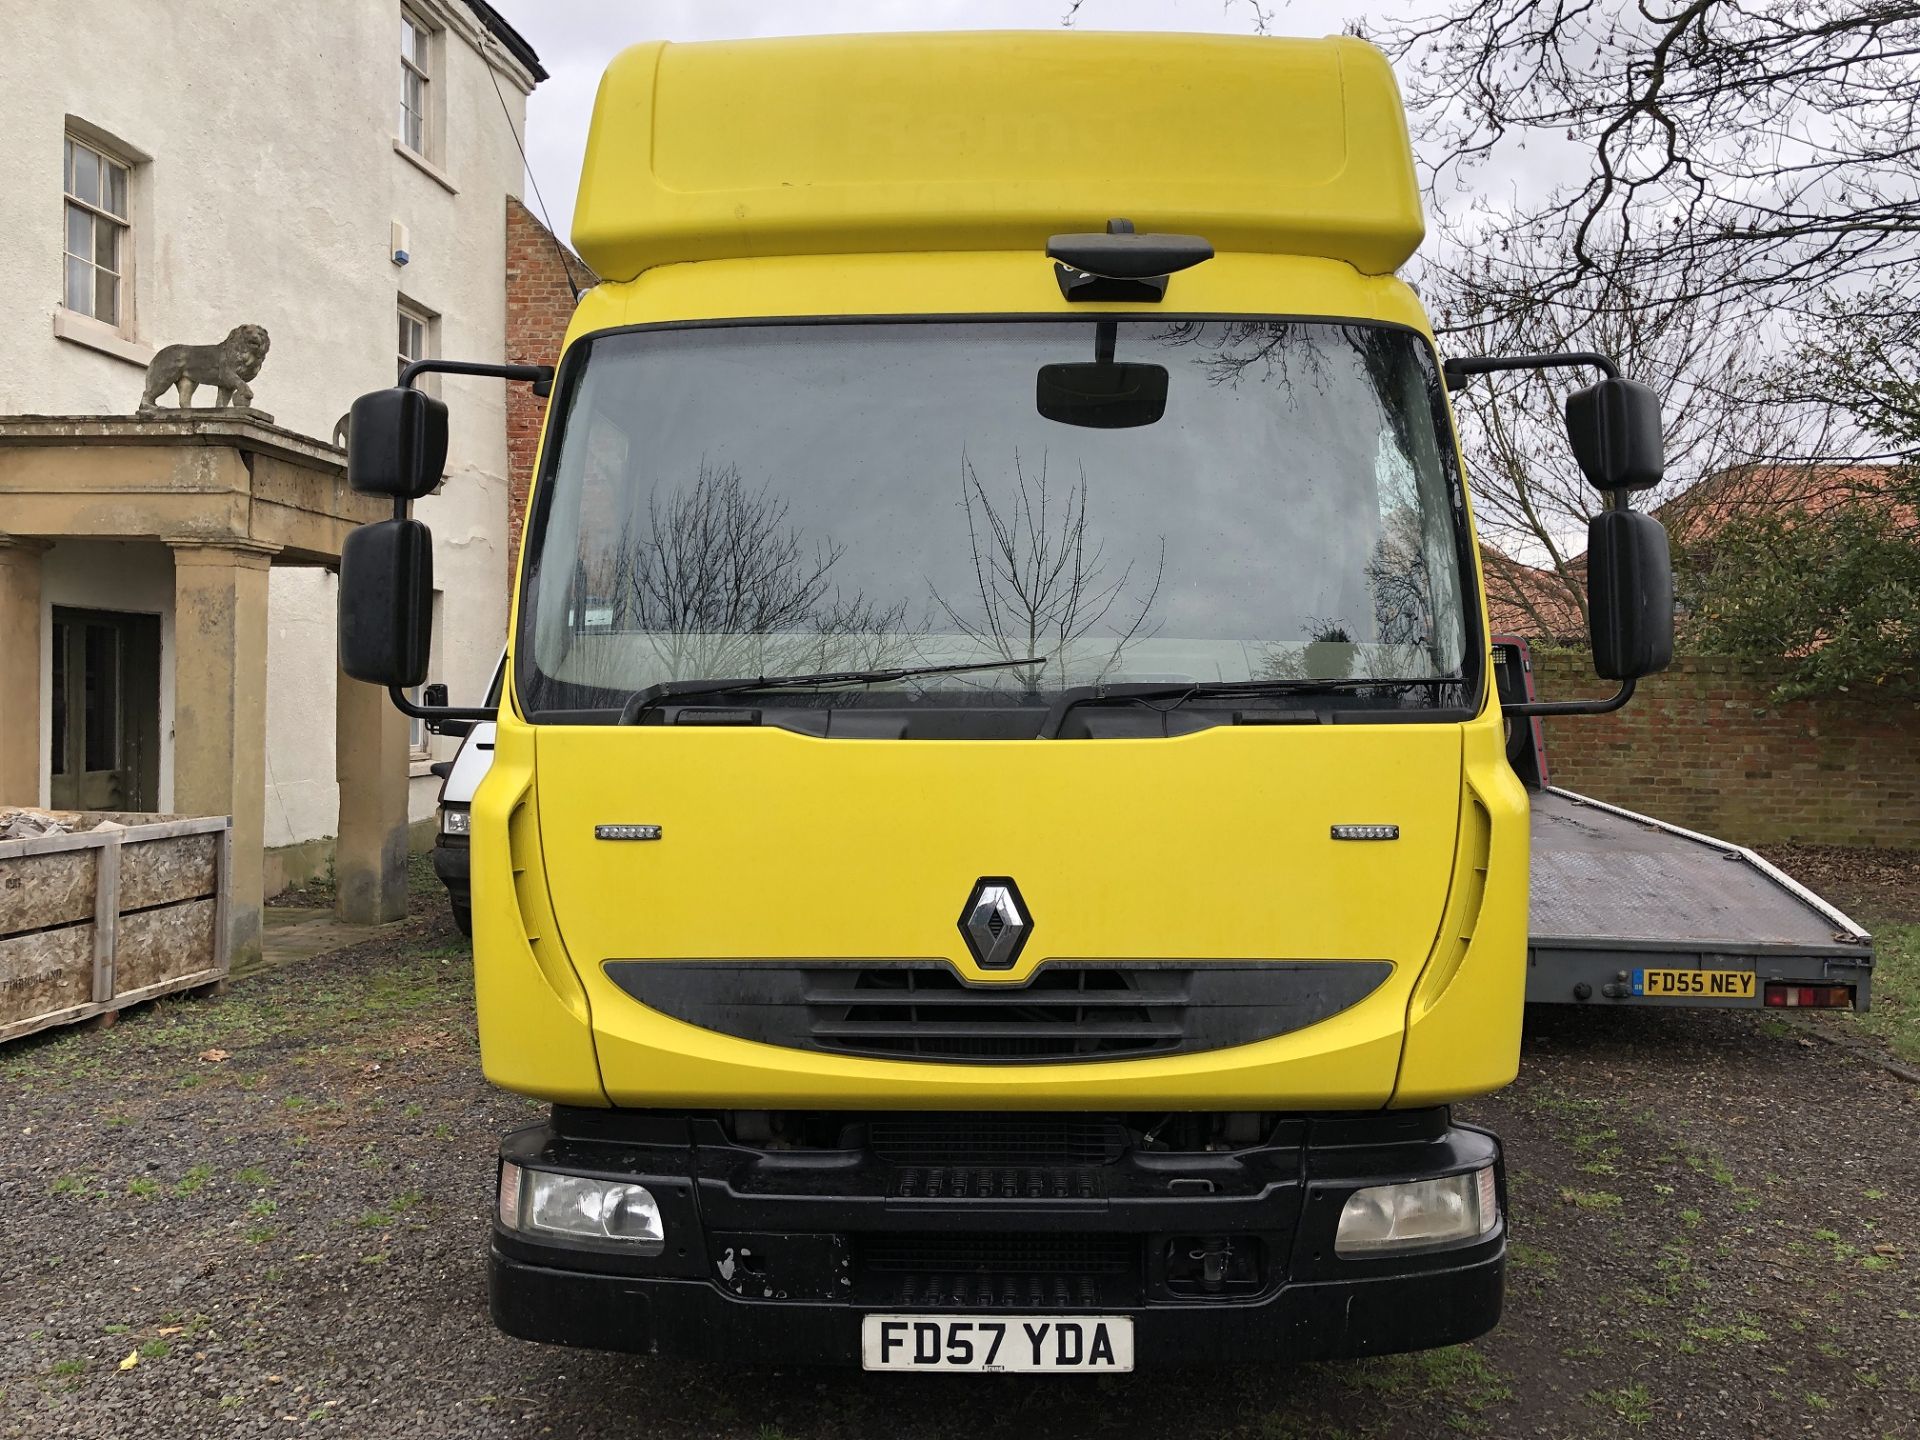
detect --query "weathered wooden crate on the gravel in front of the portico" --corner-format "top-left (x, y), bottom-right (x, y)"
top-left (0, 812), bottom-right (232, 1043)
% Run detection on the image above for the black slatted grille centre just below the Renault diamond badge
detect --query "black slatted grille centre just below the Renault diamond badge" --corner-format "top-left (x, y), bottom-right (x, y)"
top-left (806, 966), bottom-right (1190, 1062)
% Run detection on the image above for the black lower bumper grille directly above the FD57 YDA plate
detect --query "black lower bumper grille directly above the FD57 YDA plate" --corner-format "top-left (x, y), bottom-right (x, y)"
top-left (854, 1231), bottom-right (1140, 1308)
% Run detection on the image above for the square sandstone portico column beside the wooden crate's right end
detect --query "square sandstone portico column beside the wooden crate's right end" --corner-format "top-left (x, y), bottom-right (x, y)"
top-left (167, 540), bottom-right (278, 966)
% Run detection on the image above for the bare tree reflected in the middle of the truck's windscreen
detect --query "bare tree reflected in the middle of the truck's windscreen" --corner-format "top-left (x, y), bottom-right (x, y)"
top-left (929, 451), bottom-right (1167, 689)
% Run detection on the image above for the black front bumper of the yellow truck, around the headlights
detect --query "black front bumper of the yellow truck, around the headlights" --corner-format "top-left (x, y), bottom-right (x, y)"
top-left (490, 1112), bottom-right (1507, 1369)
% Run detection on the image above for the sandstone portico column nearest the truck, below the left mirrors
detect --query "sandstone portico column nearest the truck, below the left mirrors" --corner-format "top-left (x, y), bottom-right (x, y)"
top-left (334, 672), bottom-right (409, 925)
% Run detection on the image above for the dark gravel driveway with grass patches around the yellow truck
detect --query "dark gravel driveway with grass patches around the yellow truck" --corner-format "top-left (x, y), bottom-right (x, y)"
top-left (0, 916), bottom-right (1920, 1440)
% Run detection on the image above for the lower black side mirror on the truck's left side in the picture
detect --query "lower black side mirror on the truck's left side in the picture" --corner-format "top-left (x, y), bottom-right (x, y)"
top-left (340, 518), bottom-right (434, 689)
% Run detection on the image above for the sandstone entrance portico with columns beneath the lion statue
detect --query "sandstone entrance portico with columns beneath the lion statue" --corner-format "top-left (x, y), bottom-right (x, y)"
top-left (0, 409), bottom-right (409, 966)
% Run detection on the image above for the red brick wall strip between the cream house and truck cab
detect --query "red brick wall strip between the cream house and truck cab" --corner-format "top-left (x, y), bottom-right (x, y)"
top-left (507, 196), bottom-right (597, 586)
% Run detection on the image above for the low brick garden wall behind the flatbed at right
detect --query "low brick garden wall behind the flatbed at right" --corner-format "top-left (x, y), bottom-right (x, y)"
top-left (1534, 651), bottom-right (1920, 851)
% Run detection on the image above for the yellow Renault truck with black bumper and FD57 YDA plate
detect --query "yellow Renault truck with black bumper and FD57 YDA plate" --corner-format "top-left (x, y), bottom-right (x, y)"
top-left (340, 33), bottom-right (1672, 1373)
